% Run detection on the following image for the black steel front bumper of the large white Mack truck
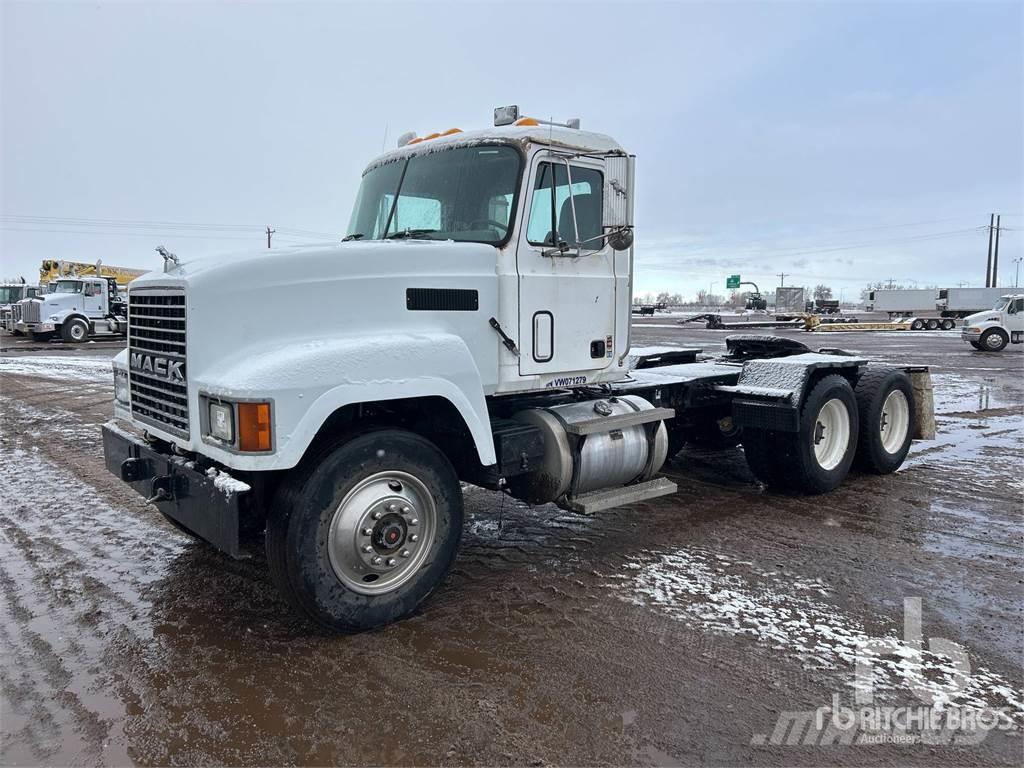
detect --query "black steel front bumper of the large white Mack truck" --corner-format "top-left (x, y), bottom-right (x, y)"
top-left (103, 423), bottom-right (247, 557)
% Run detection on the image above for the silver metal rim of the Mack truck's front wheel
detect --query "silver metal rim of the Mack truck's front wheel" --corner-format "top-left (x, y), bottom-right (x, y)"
top-left (328, 471), bottom-right (437, 595)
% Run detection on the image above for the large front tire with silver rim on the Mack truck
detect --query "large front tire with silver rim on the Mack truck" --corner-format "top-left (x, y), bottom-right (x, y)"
top-left (266, 430), bottom-right (463, 632)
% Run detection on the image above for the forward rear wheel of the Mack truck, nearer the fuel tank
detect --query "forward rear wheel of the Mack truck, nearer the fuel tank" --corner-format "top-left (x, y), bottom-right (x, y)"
top-left (743, 374), bottom-right (858, 494)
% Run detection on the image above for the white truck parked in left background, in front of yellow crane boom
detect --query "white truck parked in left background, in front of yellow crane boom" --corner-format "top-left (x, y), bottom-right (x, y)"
top-left (15, 278), bottom-right (127, 343)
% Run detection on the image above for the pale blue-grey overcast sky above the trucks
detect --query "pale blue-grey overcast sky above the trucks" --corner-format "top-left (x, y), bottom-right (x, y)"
top-left (0, 0), bottom-right (1024, 298)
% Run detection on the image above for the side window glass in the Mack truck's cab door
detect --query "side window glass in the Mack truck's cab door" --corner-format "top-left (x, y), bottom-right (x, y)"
top-left (526, 163), bottom-right (604, 251)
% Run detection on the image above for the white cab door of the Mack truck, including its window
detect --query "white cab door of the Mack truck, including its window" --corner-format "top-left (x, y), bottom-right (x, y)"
top-left (516, 153), bottom-right (616, 376)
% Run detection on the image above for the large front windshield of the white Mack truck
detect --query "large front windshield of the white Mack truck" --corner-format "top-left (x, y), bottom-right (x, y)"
top-left (346, 144), bottom-right (521, 245)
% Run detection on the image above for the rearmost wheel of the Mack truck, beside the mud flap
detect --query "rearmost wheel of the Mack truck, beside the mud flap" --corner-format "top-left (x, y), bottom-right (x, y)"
top-left (854, 368), bottom-right (914, 475)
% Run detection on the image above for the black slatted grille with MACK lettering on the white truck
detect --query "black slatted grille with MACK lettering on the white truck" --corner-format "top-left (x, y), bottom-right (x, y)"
top-left (128, 288), bottom-right (188, 437)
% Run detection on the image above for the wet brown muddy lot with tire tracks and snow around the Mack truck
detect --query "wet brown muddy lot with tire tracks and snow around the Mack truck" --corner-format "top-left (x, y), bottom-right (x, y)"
top-left (0, 325), bottom-right (1024, 766)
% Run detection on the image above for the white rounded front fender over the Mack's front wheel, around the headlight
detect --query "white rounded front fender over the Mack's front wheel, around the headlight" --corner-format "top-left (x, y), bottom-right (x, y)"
top-left (190, 333), bottom-right (496, 471)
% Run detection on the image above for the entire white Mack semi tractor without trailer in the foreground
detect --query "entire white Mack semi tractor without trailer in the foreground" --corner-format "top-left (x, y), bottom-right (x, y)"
top-left (103, 108), bottom-right (934, 631)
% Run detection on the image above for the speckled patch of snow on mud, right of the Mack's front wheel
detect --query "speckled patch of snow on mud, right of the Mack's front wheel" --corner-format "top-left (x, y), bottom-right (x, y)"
top-left (606, 549), bottom-right (1024, 722)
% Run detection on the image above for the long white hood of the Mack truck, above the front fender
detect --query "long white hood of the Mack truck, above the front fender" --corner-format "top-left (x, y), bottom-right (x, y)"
top-left (129, 240), bottom-right (498, 391)
